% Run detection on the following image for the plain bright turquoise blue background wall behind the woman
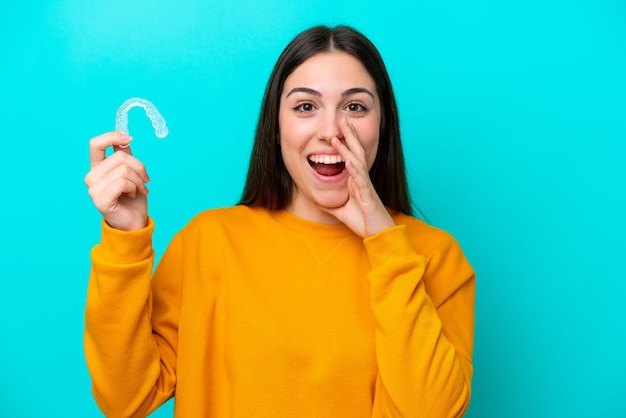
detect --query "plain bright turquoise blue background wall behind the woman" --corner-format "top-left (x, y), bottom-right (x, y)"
top-left (0, 0), bottom-right (626, 417)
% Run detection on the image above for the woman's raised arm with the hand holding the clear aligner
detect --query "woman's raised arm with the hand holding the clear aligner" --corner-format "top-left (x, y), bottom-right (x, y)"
top-left (85, 132), bottom-right (178, 417)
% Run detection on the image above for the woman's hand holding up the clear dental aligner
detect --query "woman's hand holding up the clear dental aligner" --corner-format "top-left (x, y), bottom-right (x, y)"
top-left (85, 132), bottom-right (150, 231)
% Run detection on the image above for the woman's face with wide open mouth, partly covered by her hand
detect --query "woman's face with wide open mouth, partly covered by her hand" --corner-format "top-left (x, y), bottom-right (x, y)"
top-left (278, 52), bottom-right (381, 223)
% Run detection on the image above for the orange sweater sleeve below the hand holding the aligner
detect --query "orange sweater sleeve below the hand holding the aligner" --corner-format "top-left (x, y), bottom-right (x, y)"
top-left (84, 220), bottom-right (179, 417)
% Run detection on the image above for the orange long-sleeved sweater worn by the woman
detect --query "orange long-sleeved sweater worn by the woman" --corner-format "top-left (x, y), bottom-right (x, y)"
top-left (85, 206), bottom-right (475, 418)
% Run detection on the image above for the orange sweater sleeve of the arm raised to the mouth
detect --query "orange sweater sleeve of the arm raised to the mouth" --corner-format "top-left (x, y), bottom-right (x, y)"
top-left (365, 225), bottom-right (475, 418)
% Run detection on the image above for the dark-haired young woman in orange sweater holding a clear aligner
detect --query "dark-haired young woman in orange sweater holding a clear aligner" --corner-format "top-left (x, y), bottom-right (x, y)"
top-left (85, 27), bottom-right (475, 418)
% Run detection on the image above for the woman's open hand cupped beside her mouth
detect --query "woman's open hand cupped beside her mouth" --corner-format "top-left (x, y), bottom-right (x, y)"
top-left (319, 118), bottom-right (395, 238)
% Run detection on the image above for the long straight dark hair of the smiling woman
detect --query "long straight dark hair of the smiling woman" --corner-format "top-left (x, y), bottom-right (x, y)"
top-left (239, 26), bottom-right (412, 215)
